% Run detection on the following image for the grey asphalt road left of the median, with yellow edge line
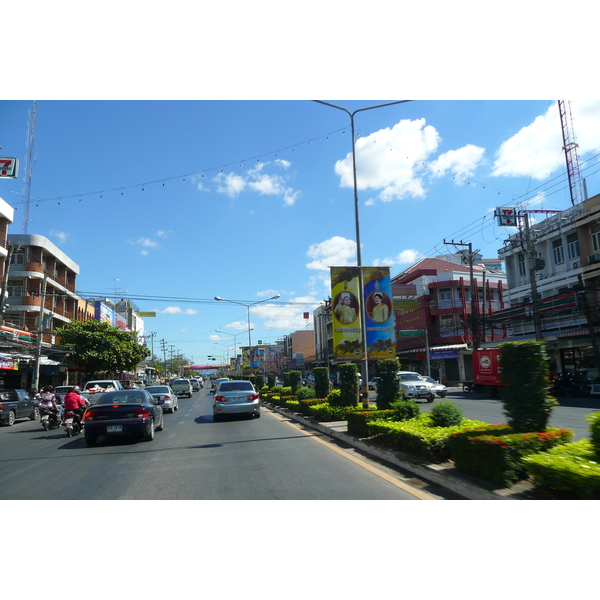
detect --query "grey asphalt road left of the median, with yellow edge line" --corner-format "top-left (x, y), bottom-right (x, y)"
top-left (0, 389), bottom-right (452, 500)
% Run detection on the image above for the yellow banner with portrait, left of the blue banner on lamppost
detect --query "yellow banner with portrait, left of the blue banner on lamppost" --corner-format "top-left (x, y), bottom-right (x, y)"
top-left (329, 267), bottom-right (362, 360)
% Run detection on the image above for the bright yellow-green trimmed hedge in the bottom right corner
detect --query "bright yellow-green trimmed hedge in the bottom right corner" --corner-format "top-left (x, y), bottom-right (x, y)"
top-left (523, 440), bottom-right (600, 500)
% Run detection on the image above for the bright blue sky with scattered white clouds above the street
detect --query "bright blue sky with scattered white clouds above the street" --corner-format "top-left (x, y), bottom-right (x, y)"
top-left (0, 99), bottom-right (600, 364)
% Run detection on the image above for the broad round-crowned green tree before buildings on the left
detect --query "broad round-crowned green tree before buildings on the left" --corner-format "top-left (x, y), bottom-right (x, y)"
top-left (59, 321), bottom-right (150, 373)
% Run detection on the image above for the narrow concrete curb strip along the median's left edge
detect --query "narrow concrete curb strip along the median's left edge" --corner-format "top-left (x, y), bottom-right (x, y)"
top-left (261, 400), bottom-right (533, 500)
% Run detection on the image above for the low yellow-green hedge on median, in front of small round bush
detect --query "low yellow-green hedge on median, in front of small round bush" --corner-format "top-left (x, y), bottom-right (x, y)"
top-left (369, 413), bottom-right (485, 463)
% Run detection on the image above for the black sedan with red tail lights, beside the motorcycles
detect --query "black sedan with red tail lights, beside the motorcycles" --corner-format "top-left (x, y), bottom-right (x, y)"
top-left (84, 389), bottom-right (164, 446)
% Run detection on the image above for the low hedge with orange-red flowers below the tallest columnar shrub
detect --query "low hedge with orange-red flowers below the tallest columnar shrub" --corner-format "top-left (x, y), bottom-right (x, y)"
top-left (448, 424), bottom-right (573, 487)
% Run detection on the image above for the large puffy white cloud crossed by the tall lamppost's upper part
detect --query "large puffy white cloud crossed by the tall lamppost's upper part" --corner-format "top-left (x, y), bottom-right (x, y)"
top-left (334, 119), bottom-right (440, 204)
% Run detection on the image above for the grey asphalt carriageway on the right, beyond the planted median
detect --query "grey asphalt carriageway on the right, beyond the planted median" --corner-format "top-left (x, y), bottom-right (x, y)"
top-left (419, 387), bottom-right (600, 440)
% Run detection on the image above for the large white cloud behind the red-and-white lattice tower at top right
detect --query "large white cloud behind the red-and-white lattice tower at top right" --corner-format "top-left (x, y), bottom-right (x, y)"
top-left (492, 100), bottom-right (600, 180)
